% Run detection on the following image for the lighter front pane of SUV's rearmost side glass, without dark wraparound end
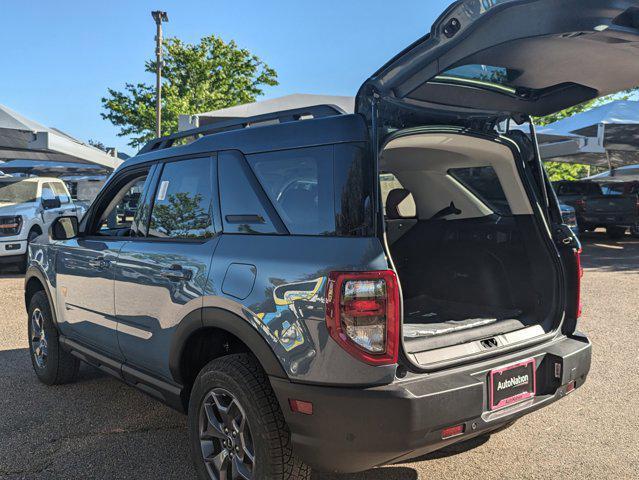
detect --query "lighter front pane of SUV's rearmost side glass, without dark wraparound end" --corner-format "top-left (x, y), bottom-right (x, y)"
top-left (247, 146), bottom-right (335, 235)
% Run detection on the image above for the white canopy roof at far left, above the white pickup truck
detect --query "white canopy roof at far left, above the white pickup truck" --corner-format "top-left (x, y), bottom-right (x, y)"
top-left (0, 105), bottom-right (122, 170)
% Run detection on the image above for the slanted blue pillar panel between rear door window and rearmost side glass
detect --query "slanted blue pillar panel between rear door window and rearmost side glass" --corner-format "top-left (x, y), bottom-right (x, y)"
top-left (218, 152), bottom-right (277, 234)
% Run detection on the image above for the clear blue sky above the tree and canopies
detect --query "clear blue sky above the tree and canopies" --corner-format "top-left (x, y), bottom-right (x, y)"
top-left (0, 0), bottom-right (452, 154)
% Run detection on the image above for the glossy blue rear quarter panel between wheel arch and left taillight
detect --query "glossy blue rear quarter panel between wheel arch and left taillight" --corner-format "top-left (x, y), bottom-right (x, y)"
top-left (204, 235), bottom-right (395, 385)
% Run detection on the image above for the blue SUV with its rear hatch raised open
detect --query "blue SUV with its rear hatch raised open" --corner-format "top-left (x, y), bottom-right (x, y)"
top-left (25, 0), bottom-right (639, 480)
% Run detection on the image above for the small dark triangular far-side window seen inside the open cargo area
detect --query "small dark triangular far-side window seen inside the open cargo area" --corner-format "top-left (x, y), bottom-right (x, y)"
top-left (448, 167), bottom-right (512, 216)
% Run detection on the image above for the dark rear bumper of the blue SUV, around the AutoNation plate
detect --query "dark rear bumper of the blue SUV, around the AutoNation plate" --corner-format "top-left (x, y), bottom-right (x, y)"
top-left (271, 336), bottom-right (591, 473)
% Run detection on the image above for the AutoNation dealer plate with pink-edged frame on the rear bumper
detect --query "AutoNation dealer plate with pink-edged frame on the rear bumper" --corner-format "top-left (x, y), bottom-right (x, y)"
top-left (488, 358), bottom-right (537, 411)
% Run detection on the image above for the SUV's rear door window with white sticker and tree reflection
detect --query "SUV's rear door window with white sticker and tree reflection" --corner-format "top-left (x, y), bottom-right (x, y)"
top-left (148, 158), bottom-right (215, 239)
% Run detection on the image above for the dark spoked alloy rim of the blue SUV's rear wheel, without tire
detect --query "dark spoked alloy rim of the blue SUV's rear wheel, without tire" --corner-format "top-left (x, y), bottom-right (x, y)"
top-left (199, 388), bottom-right (255, 480)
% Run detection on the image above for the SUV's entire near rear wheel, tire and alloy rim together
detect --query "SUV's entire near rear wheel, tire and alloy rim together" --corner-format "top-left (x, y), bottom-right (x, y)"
top-left (188, 354), bottom-right (311, 480)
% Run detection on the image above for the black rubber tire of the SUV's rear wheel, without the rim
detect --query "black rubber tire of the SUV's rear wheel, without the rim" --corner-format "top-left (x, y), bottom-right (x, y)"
top-left (188, 354), bottom-right (311, 480)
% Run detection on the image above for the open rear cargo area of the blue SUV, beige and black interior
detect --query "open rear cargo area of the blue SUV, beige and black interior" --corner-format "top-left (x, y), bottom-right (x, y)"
top-left (380, 133), bottom-right (558, 364)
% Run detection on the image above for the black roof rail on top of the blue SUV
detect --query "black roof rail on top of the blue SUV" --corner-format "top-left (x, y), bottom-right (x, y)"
top-left (138, 105), bottom-right (346, 154)
